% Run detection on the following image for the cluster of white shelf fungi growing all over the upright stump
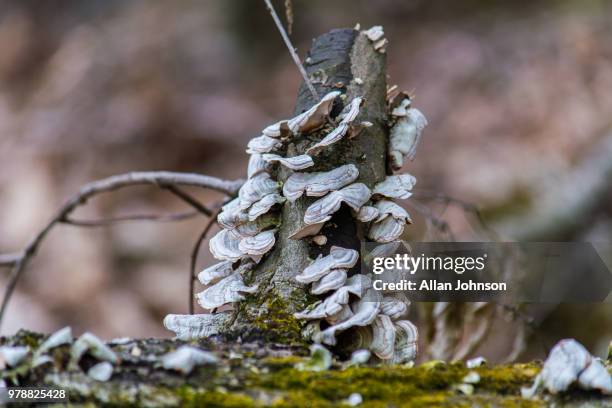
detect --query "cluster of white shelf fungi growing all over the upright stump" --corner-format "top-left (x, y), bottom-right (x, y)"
top-left (164, 27), bottom-right (427, 363)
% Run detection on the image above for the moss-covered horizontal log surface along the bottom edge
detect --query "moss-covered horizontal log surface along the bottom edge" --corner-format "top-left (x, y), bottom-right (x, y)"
top-left (0, 332), bottom-right (612, 407)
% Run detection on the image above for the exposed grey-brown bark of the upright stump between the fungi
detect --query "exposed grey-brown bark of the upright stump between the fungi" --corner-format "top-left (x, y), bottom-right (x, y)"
top-left (225, 29), bottom-right (388, 342)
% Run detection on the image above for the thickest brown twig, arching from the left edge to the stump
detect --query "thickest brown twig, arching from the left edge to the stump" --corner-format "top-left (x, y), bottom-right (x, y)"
top-left (0, 171), bottom-right (243, 326)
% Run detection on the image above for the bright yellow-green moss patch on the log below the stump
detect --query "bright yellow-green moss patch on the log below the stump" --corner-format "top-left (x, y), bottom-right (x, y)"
top-left (248, 359), bottom-right (541, 407)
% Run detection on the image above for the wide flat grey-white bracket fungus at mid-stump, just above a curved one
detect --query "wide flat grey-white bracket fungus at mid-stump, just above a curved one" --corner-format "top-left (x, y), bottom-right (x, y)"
top-left (283, 164), bottom-right (359, 202)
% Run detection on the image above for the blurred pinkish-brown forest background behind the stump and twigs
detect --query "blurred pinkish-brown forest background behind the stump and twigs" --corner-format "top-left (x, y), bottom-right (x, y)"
top-left (0, 0), bottom-right (612, 364)
